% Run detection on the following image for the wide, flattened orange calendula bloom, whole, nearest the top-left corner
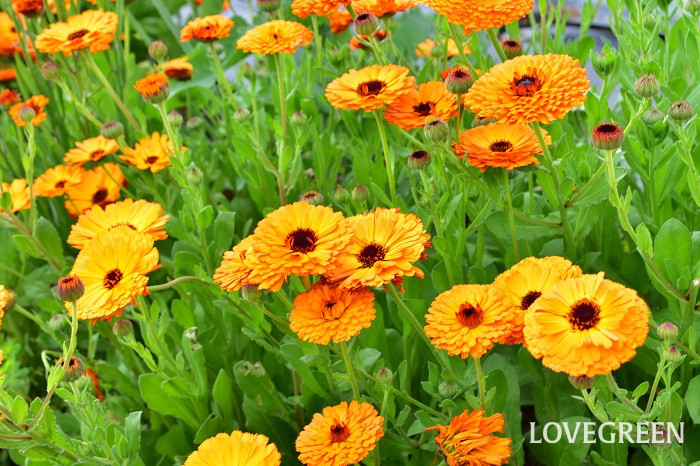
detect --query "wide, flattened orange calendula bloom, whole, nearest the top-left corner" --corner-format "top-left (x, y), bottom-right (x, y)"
top-left (35, 10), bottom-right (119, 55)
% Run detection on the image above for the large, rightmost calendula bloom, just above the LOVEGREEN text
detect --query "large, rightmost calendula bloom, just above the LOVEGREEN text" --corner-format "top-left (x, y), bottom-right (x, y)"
top-left (523, 272), bottom-right (649, 377)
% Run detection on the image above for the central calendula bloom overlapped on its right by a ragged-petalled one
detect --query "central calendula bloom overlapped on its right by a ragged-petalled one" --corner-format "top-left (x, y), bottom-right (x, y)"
top-left (250, 201), bottom-right (352, 291)
